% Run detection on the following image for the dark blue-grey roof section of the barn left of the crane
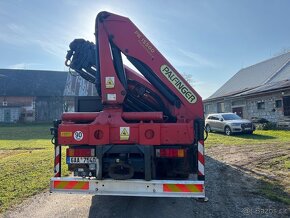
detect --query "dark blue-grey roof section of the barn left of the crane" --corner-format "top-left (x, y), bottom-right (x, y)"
top-left (0, 69), bottom-right (68, 96)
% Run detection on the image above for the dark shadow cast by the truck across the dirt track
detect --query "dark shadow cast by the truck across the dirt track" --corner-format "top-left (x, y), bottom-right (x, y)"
top-left (89, 157), bottom-right (290, 218)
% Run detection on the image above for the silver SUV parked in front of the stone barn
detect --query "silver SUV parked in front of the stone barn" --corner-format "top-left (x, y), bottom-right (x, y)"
top-left (205, 113), bottom-right (255, 135)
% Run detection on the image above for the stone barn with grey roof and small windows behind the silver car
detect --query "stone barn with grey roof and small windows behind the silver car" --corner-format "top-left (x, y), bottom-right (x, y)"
top-left (204, 52), bottom-right (290, 126)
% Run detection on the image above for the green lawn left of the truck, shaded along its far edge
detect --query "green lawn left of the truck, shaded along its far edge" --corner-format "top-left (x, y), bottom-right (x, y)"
top-left (0, 124), bottom-right (67, 212)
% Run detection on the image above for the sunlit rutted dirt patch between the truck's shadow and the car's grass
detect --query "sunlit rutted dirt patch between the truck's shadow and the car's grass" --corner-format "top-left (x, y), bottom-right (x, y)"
top-left (207, 143), bottom-right (290, 195)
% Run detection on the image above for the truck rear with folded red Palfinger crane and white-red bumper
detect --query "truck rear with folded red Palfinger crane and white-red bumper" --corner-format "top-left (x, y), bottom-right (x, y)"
top-left (50, 12), bottom-right (205, 198)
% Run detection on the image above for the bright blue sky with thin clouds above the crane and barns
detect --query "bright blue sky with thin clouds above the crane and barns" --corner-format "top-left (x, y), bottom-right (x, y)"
top-left (0, 0), bottom-right (290, 98)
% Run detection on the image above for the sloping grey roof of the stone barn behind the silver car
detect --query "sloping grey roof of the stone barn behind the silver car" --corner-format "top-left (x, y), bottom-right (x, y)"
top-left (206, 52), bottom-right (290, 101)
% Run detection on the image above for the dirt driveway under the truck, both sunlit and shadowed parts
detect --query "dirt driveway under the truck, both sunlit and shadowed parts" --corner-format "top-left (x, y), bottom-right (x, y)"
top-left (0, 145), bottom-right (290, 218)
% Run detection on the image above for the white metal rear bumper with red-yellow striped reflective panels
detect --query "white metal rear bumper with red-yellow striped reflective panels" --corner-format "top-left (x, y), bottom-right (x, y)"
top-left (50, 177), bottom-right (205, 198)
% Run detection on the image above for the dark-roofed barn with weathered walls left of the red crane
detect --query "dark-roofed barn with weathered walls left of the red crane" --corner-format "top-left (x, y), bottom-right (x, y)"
top-left (0, 69), bottom-right (98, 123)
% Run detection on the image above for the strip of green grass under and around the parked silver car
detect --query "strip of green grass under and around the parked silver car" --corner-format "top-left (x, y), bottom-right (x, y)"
top-left (205, 130), bottom-right (290, 147)
